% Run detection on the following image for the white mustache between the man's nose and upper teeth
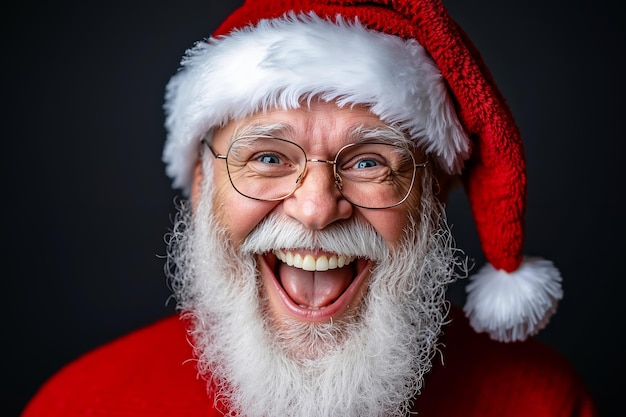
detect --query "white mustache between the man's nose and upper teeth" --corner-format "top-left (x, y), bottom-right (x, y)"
top-left (241, 214), bottom-right (389, 262)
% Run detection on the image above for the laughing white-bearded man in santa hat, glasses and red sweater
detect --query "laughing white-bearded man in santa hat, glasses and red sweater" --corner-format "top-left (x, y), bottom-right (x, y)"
top-left (19, 0), bottom-right (595, 416)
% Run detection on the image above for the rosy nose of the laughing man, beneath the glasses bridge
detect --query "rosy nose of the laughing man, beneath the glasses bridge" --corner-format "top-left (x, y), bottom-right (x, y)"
top-left (283, 160), bottom-right (353, 230)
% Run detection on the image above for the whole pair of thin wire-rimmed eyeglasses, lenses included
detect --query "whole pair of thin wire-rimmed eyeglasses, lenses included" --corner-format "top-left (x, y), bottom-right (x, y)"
top-left (202, 135), bottom-right (428, 209)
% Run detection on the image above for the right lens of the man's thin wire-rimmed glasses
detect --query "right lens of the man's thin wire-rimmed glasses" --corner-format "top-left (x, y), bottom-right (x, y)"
top-left (337, 143), bottom-right (415, 208)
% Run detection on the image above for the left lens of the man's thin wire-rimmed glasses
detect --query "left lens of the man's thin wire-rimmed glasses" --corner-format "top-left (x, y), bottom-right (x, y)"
top-left (226, 136), bottom-right (306, 200)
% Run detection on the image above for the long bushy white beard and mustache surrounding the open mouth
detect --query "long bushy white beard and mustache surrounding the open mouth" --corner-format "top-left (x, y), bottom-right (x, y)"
top-left (168, 171), bottom-right (463, 417)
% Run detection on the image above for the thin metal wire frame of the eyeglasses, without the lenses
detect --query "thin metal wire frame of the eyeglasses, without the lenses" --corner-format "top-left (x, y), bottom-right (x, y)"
top-left (201, 135), bottom-right (429, 210)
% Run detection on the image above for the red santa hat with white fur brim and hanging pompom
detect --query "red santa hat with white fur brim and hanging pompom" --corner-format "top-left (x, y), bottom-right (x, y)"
top-left (163, 0), bottom-right (562, 341)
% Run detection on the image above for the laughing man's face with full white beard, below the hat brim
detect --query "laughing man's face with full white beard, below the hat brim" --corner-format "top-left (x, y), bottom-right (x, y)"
top-left (173, 101), bottom-right (458, 417)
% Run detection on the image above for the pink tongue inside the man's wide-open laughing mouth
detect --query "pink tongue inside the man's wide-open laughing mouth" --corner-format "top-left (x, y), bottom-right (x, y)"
top-left (278, 263), bottom-right (352, 308)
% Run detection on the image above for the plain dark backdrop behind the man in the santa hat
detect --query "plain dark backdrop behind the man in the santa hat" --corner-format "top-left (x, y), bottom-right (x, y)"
top-left (1, 0), bottom-right (626, 416)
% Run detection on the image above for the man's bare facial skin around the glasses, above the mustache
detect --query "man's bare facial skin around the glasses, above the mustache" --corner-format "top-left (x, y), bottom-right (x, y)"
top-left (192, 102), bottom-right (419, 247)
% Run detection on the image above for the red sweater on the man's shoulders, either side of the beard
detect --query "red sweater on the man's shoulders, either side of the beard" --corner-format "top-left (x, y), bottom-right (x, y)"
top-left (22, 311), bottom-right (597, 417)
